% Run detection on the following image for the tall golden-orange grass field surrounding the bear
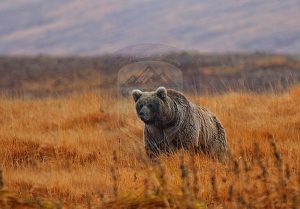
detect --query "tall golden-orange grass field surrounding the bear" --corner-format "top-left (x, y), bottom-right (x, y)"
top-left (0, 87), bottom-right (300, 208)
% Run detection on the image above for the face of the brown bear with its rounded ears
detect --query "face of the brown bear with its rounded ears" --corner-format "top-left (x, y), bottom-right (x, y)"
top-left (132, 87), bottom-right (168, 124)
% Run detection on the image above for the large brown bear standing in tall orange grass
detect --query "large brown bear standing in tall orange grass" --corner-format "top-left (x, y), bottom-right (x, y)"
top-left (132, 87), bottom-right (227, 159)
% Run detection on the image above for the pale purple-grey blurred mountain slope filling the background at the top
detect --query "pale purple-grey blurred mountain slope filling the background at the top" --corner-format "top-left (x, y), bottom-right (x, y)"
top-left (0, 0), bottom-right (300, 55)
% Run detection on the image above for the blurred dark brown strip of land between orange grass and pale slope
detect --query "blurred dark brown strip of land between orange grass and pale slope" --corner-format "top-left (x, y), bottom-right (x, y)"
top-left (0, 52), bottom-right (300, 97)
